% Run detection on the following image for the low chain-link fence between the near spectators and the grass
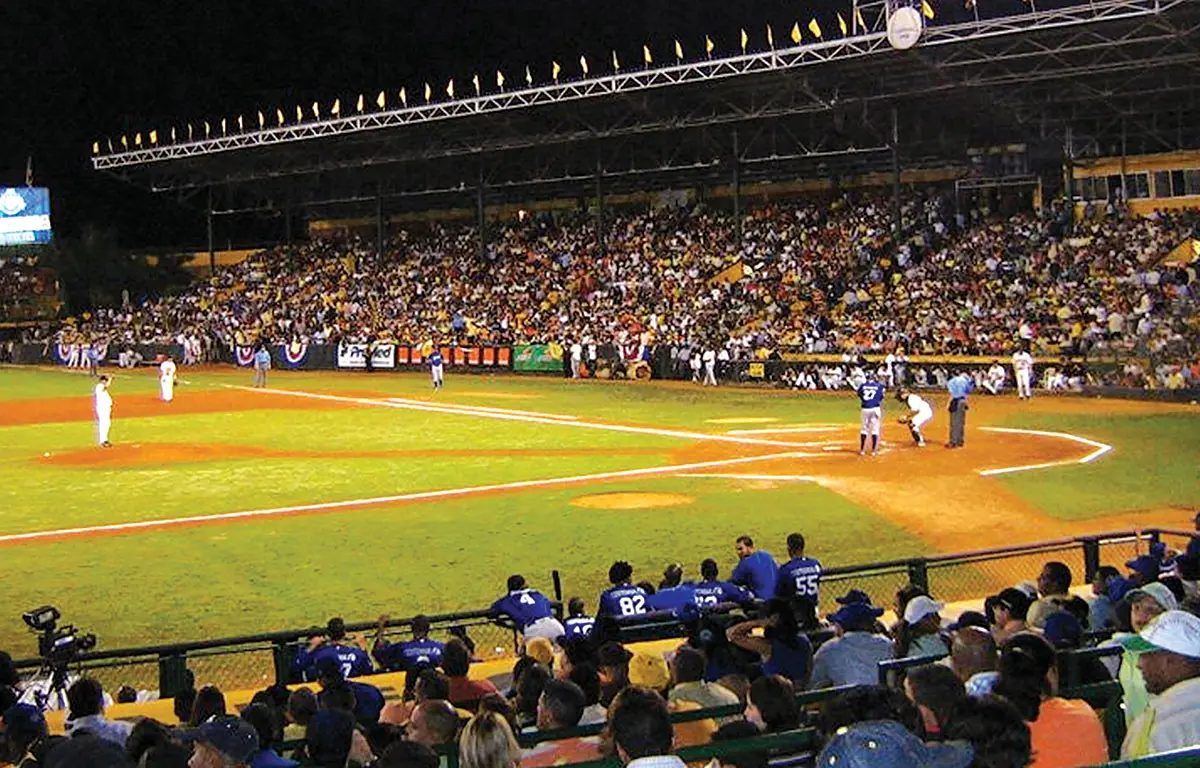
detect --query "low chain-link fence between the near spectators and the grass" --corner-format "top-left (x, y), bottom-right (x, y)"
top-left (9, 528), bottom-right (1195, 697)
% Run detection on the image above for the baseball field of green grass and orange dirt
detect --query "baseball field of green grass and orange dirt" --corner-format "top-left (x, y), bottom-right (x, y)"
top-left (0, 368), bottom-right (1200, 656)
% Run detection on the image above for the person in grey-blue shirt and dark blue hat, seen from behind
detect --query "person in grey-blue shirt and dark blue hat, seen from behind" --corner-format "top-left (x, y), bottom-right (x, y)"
top-left (809, 602), bottom-right (893, 689)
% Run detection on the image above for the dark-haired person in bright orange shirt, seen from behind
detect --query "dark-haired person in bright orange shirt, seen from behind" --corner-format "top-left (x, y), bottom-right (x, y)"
top-left (995, 632), bottom-right (1109, 768)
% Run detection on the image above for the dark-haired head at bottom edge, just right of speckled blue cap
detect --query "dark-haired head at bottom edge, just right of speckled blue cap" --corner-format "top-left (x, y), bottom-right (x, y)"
top-left (942, 696), bottom-right (1033, 768)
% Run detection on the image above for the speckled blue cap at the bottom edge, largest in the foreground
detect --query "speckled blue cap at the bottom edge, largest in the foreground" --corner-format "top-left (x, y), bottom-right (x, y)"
top-left (817, 720), bottom-right (974, 768)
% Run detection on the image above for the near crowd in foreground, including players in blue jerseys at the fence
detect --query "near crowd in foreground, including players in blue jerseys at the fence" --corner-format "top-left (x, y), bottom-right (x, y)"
top-left (7, 525), bottom-right (1200, 768)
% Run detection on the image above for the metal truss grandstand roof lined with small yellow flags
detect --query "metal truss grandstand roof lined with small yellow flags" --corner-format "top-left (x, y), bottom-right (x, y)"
top-left (92, 0), bottom-right (1200, 215)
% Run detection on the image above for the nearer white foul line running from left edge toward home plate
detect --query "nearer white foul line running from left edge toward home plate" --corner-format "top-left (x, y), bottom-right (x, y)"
top-left (0, 452), bottom-right (809, 545)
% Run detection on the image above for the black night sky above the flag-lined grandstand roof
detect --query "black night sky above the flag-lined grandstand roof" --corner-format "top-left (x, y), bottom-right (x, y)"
top-left (0, 0), bottom-right (1027, 246)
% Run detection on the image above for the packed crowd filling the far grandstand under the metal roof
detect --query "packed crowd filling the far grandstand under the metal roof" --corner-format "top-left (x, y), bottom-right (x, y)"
top-left (25, 190), bottom-right (1200, 376)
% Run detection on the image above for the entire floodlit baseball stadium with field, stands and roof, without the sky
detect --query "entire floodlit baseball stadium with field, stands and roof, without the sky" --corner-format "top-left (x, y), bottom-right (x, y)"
top-left (0, 0), bottom-right (1200, 768)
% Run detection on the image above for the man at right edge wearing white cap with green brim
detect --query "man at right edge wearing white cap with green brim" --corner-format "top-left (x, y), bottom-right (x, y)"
top-left (1121, 611), bottom-right (1200, 760)
